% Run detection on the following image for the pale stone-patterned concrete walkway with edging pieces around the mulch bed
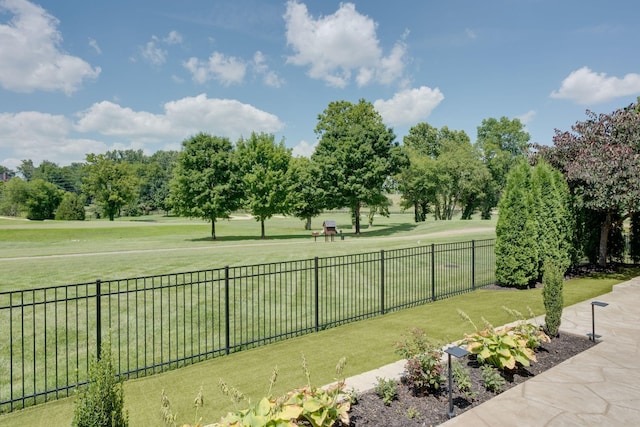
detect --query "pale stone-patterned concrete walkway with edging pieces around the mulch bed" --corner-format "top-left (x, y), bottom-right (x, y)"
top-left (347, 277), bottom-right (640, 427)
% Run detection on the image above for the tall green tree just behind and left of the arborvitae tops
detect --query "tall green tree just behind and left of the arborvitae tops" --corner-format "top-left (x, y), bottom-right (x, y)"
top-left (476, 117), bottom-right (531, 219)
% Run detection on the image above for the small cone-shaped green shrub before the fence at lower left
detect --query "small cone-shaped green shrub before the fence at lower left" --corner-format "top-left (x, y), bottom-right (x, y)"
top-left (71, 340), bottom-right (129, 427)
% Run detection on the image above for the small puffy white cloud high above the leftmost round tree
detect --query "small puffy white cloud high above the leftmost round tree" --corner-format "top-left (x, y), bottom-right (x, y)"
top-left (183, 52), bottom-right (247, 86)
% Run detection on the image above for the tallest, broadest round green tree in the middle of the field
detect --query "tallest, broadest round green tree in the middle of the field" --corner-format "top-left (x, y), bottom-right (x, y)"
top-left (311, 99), bottom-right (407, 234)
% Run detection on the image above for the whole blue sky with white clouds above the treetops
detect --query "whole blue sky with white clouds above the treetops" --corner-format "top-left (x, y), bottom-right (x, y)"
top-left (0, 0), bottom-right (640, 169)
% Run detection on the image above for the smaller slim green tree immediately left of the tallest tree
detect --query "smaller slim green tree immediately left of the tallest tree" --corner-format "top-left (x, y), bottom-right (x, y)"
top-left (287, 157), bottom-right (325, 230)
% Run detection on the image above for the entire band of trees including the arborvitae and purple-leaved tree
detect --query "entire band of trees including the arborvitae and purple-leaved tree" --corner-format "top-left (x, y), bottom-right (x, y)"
top-left (0, 100), bottom-right (640, 270)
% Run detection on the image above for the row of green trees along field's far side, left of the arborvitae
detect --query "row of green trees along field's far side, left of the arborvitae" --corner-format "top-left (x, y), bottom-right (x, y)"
top-left (0, 100), bottom-right (529, 239)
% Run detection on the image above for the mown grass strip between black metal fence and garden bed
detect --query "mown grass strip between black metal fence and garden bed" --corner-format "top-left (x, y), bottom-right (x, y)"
top-left (0, 269), bottom-right (640, 427)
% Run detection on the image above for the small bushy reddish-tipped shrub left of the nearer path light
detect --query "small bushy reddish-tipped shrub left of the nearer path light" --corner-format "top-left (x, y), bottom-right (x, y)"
top-left (396, 329), bottom-right (445, 394)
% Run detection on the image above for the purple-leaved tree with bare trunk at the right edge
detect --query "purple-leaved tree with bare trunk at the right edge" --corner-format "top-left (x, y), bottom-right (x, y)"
top-left (538, 103), bottom-right (640, 266)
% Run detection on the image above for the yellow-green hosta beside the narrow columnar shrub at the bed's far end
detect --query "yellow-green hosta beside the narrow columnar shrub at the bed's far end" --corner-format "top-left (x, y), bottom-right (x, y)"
top-left (458, 310), bottom-right (536, 369)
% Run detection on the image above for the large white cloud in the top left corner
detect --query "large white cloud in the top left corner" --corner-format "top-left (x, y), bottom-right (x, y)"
top-left (0, 0), bottom-right (100, 95)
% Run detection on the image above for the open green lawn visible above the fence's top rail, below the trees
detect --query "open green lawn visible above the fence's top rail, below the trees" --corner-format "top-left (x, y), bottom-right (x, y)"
top-left (0, 213), bottom-right (495, 292)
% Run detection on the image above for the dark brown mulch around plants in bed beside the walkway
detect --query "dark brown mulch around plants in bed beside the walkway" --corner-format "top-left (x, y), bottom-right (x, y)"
top-left (350, 334), bottom-right (594, 427)
